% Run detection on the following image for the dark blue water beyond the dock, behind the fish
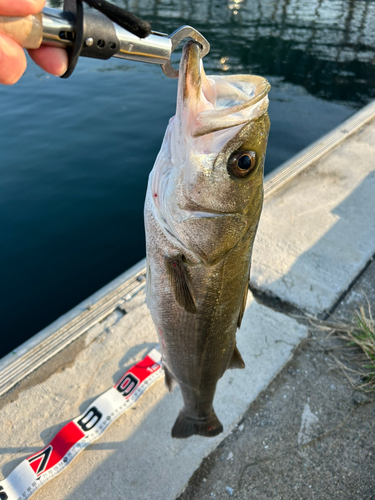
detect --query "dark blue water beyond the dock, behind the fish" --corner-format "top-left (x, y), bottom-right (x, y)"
top-left (0, 0), bottom-right (375, 357)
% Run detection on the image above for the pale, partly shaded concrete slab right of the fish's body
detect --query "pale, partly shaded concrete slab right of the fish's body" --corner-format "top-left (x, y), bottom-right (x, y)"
top-left (251, 117), bottom-right (375, 316)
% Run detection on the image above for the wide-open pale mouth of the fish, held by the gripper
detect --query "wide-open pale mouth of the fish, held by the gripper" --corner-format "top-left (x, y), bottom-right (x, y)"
top-left (176, 41), bottom-right (271, 143)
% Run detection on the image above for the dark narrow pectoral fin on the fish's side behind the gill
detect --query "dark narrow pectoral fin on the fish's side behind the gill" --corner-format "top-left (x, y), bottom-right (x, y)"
top-left (164, 255), bottom-right (197, 313)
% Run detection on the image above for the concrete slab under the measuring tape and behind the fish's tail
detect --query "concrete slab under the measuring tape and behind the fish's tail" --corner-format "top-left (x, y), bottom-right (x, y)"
top-left (0, 295), bottom-right (307, 500)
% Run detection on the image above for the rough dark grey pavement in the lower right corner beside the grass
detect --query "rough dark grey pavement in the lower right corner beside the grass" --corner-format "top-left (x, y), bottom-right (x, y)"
top-left (178, 262), bottom-right (375, 500)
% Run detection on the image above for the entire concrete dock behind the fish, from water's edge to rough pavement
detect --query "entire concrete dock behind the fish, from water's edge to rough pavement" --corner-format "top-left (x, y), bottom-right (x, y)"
top-left (0, 104), bottom-right (375, 500)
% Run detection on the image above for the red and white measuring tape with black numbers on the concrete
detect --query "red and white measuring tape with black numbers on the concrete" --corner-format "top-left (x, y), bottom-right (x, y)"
top-left (0, 349), bottom-right (163, 500)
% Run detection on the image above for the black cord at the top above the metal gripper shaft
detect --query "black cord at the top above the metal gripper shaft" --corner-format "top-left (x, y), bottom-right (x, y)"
top-left (83, 0), bottom-right (151, 38)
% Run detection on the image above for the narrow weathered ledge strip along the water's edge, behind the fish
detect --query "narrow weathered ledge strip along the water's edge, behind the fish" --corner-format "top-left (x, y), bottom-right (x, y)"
top-left (0, 101), bottom-right (375, 396)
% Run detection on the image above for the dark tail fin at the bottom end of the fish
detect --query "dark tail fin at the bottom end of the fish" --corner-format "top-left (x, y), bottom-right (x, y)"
top-left (172, 408), bottom-right (223, 439)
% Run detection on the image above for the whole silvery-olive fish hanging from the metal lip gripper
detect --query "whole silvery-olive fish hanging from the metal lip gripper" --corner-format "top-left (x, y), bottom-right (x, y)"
top-left (144, 41), bottom-right (270, 438)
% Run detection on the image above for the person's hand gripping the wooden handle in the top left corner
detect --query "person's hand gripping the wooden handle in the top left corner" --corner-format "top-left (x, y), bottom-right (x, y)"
top-left (0, 0), bottom-right (68, 85)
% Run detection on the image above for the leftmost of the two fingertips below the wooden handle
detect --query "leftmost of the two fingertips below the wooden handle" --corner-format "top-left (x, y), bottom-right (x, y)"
top-left (0, 33), bottom-right (26, 85)
